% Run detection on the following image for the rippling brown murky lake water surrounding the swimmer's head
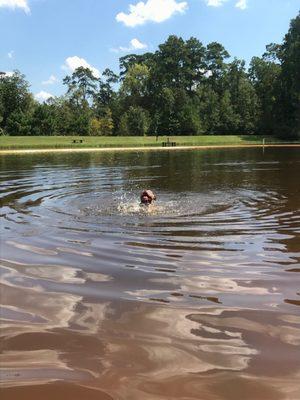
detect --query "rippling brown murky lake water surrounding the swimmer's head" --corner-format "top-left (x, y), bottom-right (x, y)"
top-left (0, 148), bottom-right (300, 400)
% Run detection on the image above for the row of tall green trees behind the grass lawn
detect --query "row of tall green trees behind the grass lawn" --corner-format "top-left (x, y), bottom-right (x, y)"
top-left (0, 13), bottom-right (300, 138)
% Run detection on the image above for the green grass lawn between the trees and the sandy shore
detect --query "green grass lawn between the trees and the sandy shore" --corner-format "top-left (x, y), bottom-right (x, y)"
top-left (0, 135), bottom-right (296, 150)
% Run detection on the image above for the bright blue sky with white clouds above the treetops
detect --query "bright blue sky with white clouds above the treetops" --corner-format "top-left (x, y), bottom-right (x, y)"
top-left (0, 0), bottom-right (300, 100)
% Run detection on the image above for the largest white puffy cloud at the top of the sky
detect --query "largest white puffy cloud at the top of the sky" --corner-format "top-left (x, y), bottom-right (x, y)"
top-left (116, 0), bottom-right (188, 27)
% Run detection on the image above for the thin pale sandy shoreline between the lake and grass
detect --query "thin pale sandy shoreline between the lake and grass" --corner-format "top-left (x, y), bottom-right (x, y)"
top-left (0, 143), bottom-right (300, 155)
